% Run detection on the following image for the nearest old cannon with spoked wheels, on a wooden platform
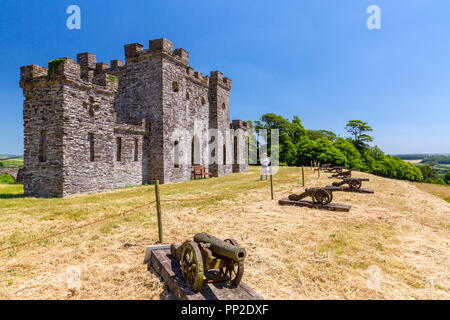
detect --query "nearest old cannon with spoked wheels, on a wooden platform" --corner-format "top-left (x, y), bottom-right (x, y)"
top-left (170, 232), bottom-right (246, 292)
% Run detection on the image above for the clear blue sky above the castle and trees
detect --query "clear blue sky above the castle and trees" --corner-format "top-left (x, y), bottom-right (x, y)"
top-left (0, 0), bottom-right (450, 154)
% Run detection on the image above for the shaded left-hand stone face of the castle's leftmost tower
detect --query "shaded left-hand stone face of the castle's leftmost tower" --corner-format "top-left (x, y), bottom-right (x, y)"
top-left (20, 65), bottom-right (64, 197)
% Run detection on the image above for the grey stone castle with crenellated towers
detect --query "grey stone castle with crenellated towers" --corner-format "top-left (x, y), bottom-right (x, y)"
top-left (20, 39), bottom-right (248, 197)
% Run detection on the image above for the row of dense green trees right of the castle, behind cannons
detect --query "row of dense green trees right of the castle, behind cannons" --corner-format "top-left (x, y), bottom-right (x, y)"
top-left (250, 113), bottom-right (424, 181)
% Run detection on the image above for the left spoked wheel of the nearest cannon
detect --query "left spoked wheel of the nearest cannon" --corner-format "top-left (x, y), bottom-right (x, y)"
top-left (180, 241), bottom-right (203, 291)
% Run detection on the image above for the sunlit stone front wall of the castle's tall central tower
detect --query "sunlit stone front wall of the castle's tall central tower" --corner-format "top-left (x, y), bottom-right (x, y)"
top-left (163, 40), bottom-right (209, 182)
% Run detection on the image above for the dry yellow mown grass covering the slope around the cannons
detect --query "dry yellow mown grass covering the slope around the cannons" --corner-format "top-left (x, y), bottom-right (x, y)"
top-left (0, 168), bottom-right (450, 299)
